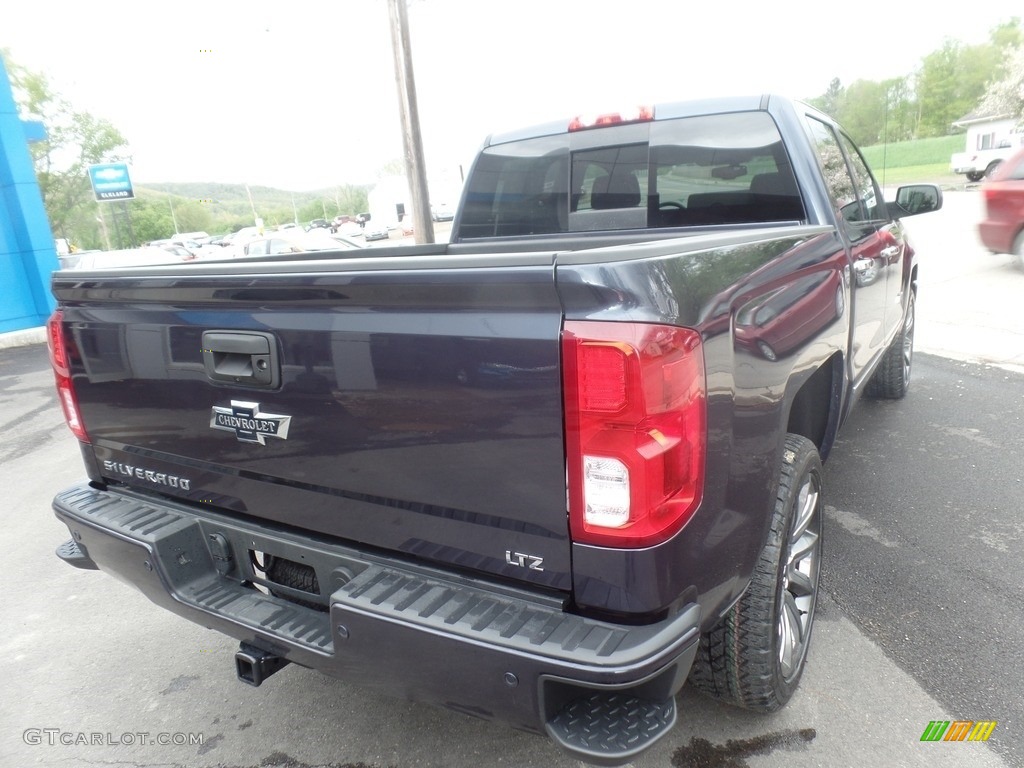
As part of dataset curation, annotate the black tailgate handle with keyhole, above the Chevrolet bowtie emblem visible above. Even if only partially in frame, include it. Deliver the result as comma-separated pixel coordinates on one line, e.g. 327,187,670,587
203,331,281,389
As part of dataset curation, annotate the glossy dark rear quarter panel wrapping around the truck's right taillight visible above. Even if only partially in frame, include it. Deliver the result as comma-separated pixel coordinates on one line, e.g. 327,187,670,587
557,226,850,623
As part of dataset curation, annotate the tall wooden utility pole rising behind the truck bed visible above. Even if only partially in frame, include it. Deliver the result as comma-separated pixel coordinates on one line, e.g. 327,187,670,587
388,0,434,243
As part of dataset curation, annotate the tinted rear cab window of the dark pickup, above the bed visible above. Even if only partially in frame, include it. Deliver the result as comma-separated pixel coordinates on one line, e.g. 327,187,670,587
460,112,806,240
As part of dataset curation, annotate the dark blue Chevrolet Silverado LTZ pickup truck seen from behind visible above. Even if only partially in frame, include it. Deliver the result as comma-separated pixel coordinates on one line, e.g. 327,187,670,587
48,95,942,765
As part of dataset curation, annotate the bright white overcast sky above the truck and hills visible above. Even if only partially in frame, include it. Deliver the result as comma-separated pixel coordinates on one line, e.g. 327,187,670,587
0,0,1024,190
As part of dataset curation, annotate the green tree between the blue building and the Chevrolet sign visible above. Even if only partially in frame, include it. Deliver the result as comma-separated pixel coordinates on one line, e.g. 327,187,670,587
2,51,128,242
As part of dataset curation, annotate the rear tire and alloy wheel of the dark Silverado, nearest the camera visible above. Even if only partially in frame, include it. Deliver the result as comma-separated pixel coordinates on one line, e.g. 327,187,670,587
689,434,823,712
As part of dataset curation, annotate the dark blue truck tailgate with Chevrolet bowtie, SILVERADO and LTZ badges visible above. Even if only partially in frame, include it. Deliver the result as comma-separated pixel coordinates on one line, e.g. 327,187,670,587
53,254,570,590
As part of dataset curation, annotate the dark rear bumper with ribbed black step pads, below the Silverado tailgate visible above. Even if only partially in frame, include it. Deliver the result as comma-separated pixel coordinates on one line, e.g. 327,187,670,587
53,484,700,764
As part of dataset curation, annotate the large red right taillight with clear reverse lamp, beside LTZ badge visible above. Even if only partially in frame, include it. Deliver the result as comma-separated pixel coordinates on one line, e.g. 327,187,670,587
562,322,707,547
